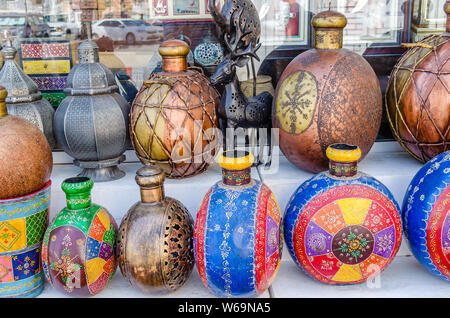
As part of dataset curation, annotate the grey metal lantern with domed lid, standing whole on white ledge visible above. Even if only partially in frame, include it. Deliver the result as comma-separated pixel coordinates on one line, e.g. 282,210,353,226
54,41,130,182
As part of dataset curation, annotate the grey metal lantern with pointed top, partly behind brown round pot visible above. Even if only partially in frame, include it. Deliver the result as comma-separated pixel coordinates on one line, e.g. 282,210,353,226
0,41,56,148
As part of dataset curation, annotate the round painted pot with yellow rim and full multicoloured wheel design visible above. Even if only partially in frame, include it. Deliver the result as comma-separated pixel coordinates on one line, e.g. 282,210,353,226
284,144,402,284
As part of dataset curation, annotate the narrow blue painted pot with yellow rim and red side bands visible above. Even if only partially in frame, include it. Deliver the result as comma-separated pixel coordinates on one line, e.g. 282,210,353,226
194,151,282,297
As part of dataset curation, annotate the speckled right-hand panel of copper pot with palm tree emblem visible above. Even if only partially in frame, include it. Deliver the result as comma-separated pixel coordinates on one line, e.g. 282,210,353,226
318,51,382,156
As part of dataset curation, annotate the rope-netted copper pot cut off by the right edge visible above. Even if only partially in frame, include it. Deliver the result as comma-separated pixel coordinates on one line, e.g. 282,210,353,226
386,1,450,162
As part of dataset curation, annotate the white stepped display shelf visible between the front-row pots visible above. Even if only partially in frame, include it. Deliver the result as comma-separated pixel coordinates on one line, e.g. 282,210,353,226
39,142,450,298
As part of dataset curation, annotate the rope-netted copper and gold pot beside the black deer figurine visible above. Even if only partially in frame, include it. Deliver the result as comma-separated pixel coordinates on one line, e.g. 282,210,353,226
130,40,219,178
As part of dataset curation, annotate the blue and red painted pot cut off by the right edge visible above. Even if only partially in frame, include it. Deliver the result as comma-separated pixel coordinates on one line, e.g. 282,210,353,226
402,151,450,281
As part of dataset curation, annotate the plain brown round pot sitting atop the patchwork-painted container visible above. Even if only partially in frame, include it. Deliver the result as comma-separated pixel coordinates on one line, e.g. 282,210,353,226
0,86,53,199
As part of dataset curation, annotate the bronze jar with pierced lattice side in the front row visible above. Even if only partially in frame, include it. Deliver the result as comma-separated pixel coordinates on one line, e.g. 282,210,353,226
116,166,195,293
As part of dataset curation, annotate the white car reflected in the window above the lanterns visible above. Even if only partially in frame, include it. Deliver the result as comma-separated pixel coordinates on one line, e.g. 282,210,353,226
92,19,163,45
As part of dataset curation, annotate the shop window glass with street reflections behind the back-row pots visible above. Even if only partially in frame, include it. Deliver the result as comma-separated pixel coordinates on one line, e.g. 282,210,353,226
0,0,445,95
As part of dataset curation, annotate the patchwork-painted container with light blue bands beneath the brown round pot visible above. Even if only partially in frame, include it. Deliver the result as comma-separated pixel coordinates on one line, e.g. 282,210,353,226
0,181,51,297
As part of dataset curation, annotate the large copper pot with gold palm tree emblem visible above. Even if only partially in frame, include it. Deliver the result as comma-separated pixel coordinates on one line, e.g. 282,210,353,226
273,11,382,173
